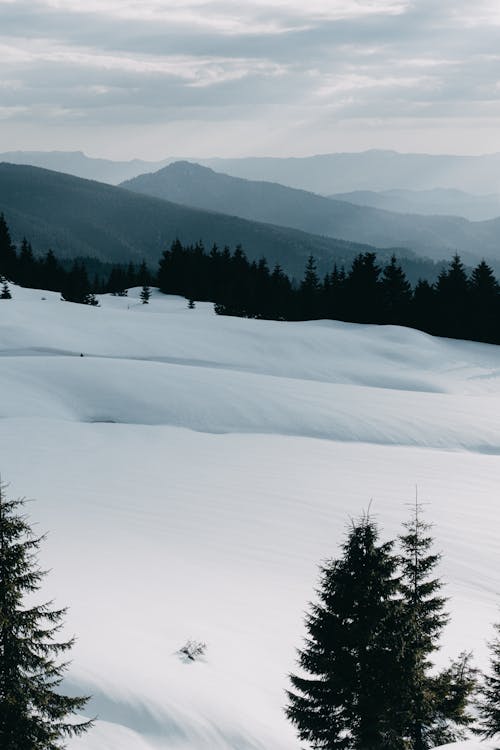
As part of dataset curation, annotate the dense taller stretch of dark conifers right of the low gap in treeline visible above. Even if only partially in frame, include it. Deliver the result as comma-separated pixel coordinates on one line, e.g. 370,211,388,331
157,240,500,343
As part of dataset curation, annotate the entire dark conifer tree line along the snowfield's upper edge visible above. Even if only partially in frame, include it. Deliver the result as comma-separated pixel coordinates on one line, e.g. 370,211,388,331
0,215,500,344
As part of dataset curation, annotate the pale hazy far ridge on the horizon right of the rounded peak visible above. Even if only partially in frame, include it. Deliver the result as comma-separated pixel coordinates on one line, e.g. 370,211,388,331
199,150,500,195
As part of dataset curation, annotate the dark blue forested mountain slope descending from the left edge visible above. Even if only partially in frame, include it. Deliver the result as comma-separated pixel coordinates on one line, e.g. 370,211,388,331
0,163,402,276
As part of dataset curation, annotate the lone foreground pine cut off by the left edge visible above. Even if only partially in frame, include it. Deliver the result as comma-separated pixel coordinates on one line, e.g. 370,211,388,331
0,484,92,750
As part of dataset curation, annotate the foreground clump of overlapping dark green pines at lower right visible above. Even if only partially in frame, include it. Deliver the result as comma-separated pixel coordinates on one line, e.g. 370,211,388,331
286,504,476,750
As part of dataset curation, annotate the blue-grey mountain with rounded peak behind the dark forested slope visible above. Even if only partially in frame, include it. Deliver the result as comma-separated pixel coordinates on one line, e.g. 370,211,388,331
122,162,500,262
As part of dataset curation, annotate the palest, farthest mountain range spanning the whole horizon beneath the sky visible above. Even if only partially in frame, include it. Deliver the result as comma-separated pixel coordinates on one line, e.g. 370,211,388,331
6,150,500,197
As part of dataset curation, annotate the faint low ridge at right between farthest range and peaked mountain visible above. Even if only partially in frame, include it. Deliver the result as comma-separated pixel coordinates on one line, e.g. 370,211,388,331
328,188,500,221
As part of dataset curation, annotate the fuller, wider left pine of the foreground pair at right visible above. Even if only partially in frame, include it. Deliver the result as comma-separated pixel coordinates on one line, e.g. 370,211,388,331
286,517,404,750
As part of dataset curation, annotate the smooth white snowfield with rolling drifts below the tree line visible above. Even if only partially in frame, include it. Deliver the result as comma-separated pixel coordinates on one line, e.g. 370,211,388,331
0,288,500,750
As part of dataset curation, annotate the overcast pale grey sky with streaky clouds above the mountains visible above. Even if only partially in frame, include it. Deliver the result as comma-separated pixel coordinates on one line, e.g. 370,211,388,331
0,0,500,159
